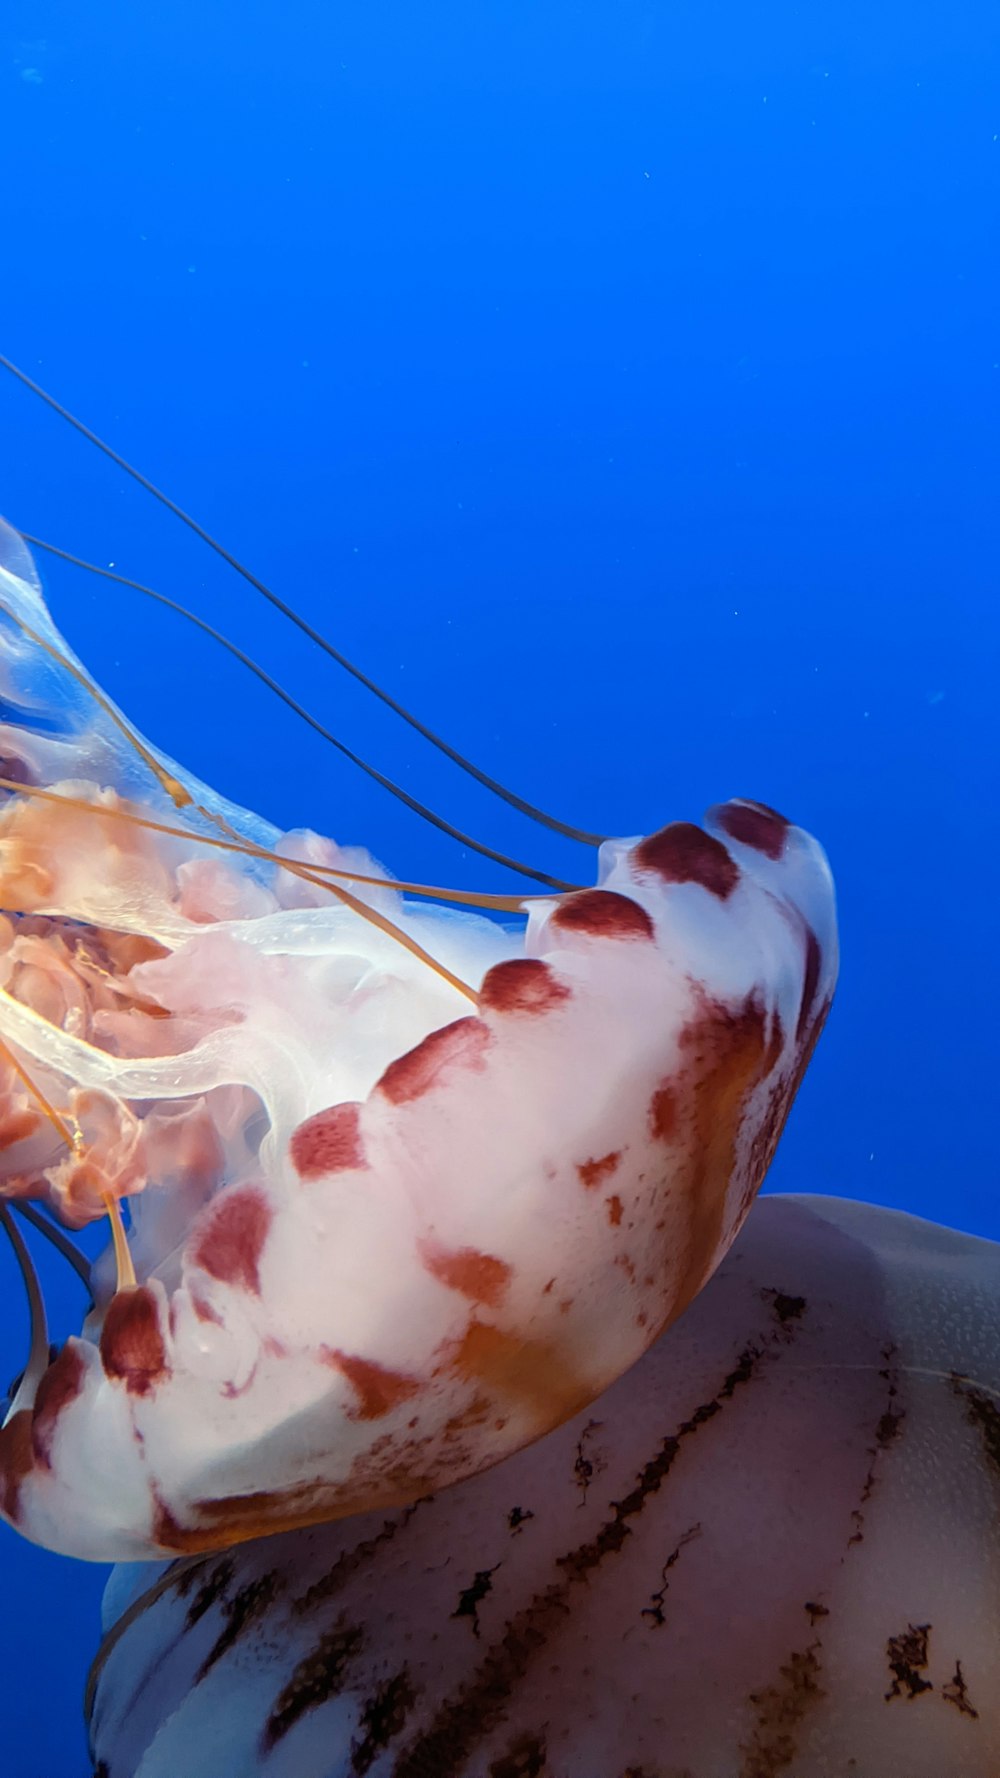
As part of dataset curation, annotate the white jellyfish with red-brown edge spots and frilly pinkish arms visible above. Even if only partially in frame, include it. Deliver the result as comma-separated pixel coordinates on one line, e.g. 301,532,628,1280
0,508,836,1559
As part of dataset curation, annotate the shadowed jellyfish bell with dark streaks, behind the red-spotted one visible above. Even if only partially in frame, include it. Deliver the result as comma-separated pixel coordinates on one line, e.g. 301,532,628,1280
91,1198,1000,1778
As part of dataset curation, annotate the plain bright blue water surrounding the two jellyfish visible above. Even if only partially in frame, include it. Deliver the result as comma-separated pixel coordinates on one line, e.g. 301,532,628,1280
0,0,1000,1778
